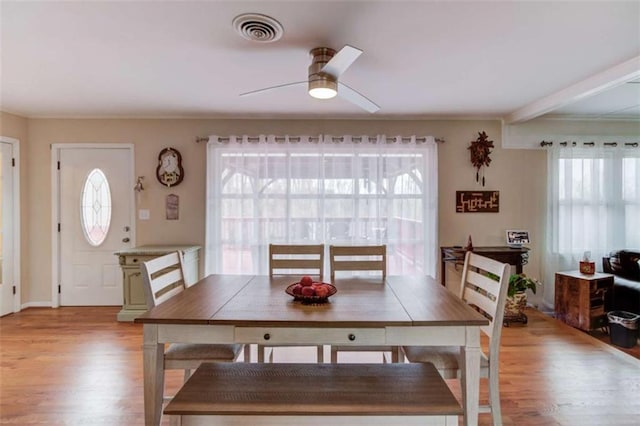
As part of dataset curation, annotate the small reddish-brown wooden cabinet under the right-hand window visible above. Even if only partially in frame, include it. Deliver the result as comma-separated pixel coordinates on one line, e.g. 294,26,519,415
555,271,613,331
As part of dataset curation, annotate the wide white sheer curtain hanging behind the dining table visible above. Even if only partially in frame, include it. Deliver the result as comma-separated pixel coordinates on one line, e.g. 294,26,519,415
205,135,438,276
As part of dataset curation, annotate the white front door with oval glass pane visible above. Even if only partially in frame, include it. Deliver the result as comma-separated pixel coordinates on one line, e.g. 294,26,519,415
58,147,134,306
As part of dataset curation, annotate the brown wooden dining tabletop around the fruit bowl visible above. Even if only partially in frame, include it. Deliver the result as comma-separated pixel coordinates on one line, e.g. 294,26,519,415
135,275,488,327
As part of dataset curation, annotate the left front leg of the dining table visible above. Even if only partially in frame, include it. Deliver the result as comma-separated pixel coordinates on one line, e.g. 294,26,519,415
142,324,164,426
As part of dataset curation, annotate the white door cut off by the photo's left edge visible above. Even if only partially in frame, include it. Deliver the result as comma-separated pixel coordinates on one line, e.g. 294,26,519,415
0,141,16,316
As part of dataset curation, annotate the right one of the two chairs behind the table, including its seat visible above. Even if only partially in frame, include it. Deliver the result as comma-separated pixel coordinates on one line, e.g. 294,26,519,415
329,244,400,364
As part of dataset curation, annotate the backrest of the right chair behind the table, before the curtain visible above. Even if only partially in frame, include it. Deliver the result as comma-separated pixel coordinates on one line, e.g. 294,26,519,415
329,245,387,279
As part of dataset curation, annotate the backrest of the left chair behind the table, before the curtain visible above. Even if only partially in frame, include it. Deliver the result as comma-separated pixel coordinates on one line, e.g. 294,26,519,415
269,244,324,278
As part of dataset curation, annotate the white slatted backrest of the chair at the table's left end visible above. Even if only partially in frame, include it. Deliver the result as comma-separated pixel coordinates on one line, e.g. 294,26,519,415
140,251,185,309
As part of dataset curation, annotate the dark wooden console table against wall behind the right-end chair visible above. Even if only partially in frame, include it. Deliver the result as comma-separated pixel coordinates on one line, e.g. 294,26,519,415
440,246,529,285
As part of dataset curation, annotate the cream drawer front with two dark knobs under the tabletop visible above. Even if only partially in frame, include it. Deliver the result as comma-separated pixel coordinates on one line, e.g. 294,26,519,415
235,327,386,346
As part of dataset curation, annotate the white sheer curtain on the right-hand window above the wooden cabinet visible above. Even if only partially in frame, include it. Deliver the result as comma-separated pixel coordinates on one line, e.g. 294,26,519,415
544,144,640,306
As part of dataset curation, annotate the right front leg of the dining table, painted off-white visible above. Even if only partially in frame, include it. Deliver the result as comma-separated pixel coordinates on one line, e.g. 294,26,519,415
460,327,480,426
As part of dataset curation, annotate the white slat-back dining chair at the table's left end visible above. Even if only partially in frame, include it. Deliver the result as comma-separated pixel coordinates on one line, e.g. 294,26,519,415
140,251,249,400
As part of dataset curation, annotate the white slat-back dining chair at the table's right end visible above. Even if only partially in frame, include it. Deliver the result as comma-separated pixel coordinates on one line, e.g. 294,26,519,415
402,251,510,425
